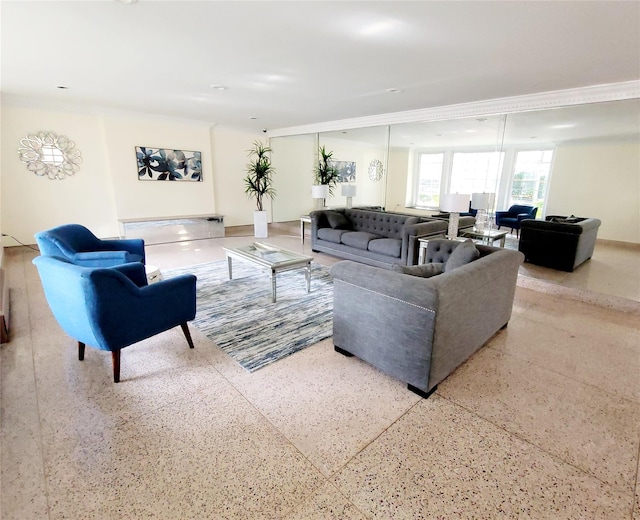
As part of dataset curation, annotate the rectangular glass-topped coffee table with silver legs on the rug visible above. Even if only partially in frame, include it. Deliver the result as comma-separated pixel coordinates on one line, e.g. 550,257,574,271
222,242,313,303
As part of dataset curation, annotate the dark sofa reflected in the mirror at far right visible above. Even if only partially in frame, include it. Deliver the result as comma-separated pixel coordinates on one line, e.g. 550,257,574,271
518,215,601,272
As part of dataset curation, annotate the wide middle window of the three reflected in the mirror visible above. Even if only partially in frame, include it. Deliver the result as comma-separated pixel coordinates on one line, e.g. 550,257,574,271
449,152,504,198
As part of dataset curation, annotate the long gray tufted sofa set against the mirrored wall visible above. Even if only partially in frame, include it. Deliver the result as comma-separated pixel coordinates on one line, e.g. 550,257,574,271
310,208,475,269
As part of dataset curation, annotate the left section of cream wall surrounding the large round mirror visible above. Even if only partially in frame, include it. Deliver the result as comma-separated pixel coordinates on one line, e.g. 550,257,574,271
0,106,118,246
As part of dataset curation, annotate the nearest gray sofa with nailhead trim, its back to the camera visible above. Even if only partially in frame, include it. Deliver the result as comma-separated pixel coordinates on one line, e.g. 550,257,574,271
331,239,524,396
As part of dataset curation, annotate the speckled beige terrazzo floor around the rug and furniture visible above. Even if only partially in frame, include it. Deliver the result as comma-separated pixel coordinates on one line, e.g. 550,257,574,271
0,229,640,520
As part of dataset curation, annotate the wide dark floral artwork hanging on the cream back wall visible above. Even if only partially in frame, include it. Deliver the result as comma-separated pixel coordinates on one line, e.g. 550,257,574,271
136,146,202,182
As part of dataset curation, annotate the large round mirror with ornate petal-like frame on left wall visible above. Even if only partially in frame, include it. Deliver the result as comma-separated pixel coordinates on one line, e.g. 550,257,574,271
18,132,82,179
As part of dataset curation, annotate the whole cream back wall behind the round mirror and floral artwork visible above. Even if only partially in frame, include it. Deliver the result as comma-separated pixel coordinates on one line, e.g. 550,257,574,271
0,105,262,246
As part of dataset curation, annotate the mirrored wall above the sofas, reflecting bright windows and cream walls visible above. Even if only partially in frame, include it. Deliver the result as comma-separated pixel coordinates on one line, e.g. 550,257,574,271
271,99,640,243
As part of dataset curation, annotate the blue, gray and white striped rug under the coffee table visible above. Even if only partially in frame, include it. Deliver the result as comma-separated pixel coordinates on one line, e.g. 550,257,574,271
162,259,333,372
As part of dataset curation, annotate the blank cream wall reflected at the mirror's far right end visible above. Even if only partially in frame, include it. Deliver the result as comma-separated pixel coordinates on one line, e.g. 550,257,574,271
546,140,640,243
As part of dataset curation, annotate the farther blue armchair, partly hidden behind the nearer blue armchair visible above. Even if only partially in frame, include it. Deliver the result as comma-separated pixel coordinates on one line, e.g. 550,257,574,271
35,224,145,267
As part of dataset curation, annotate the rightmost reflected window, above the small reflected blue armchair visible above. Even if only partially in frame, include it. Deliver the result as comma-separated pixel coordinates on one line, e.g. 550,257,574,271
509,150,553,214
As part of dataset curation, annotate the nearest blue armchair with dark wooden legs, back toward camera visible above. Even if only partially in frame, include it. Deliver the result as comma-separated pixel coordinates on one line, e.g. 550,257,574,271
33,256,196,383
